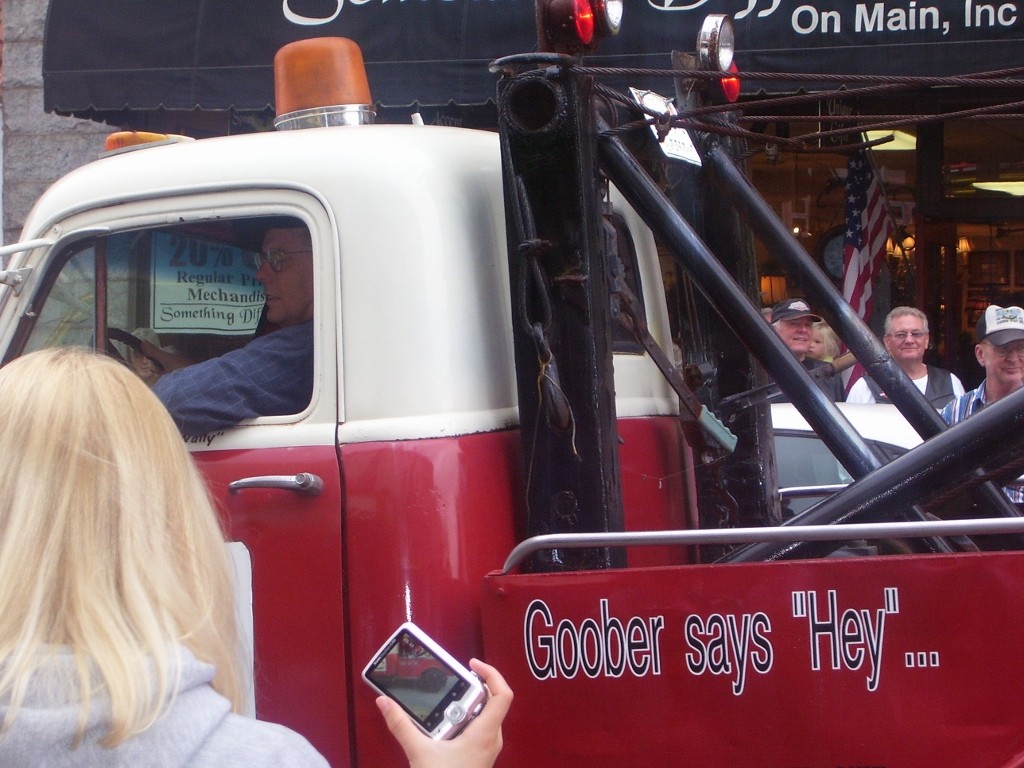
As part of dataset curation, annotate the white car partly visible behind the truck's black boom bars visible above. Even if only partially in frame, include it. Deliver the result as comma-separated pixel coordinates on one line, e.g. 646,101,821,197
771,402,922,517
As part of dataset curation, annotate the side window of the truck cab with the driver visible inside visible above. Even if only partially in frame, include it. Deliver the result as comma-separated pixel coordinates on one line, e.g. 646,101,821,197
12,217,313,434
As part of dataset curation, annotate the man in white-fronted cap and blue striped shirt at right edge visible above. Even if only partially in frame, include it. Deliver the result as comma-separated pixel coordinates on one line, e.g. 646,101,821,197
942,304,1024,505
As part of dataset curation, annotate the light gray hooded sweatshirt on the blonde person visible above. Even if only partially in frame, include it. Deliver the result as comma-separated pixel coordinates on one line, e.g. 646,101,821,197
0,649,328,768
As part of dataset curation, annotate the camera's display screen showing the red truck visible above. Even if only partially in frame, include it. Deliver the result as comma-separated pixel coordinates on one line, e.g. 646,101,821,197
367,630,469,731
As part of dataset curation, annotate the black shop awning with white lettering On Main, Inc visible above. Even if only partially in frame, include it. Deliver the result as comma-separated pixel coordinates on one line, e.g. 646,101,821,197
43,0,1024,132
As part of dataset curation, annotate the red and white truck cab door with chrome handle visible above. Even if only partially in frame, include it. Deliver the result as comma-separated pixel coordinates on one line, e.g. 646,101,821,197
6,207,350,765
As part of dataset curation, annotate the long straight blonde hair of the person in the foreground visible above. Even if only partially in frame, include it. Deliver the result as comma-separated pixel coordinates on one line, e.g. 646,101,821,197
0,348,243,746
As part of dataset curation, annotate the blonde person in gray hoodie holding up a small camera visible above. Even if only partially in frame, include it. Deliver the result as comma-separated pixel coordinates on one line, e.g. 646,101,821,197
0,348,512,768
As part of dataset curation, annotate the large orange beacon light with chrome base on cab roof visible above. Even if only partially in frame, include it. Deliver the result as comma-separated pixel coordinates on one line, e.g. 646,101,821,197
273,37,376,130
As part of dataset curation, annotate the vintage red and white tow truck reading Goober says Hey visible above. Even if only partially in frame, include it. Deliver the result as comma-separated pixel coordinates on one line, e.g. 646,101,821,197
0,7,1024,768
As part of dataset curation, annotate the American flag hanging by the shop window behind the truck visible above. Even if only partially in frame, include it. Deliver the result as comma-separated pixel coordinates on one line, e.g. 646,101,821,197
843,150,893,391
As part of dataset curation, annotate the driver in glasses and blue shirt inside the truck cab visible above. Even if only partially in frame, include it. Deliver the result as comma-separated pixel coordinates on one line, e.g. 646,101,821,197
141,219,313,435
